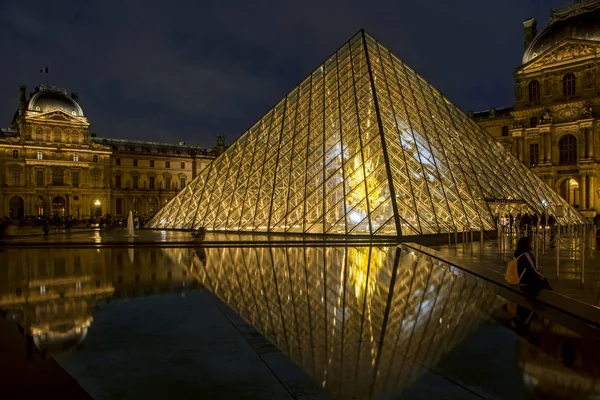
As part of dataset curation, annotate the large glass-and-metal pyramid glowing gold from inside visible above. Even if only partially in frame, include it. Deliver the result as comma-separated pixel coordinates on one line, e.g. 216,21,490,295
148,31,583,236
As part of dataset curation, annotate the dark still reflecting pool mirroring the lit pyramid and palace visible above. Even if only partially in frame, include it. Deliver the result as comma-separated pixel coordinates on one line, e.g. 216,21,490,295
0,244,600,399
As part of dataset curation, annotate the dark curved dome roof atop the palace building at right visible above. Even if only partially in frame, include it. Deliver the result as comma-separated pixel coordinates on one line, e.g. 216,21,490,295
523,0,600,64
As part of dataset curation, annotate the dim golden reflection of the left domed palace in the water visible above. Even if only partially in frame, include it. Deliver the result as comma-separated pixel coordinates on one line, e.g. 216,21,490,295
0,248,198,352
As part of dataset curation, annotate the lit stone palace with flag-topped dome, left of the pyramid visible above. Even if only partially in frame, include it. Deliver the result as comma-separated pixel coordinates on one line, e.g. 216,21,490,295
0,85,218,220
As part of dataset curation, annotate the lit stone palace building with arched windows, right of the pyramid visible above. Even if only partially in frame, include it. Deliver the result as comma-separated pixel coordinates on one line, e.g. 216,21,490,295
472,0,600,217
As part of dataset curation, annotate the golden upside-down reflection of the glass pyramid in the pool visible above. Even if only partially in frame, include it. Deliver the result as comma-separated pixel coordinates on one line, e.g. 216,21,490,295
176,246,502,399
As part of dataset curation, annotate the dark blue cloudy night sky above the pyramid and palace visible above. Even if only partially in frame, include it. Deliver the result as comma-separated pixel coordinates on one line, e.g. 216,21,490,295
0,0,572,147
